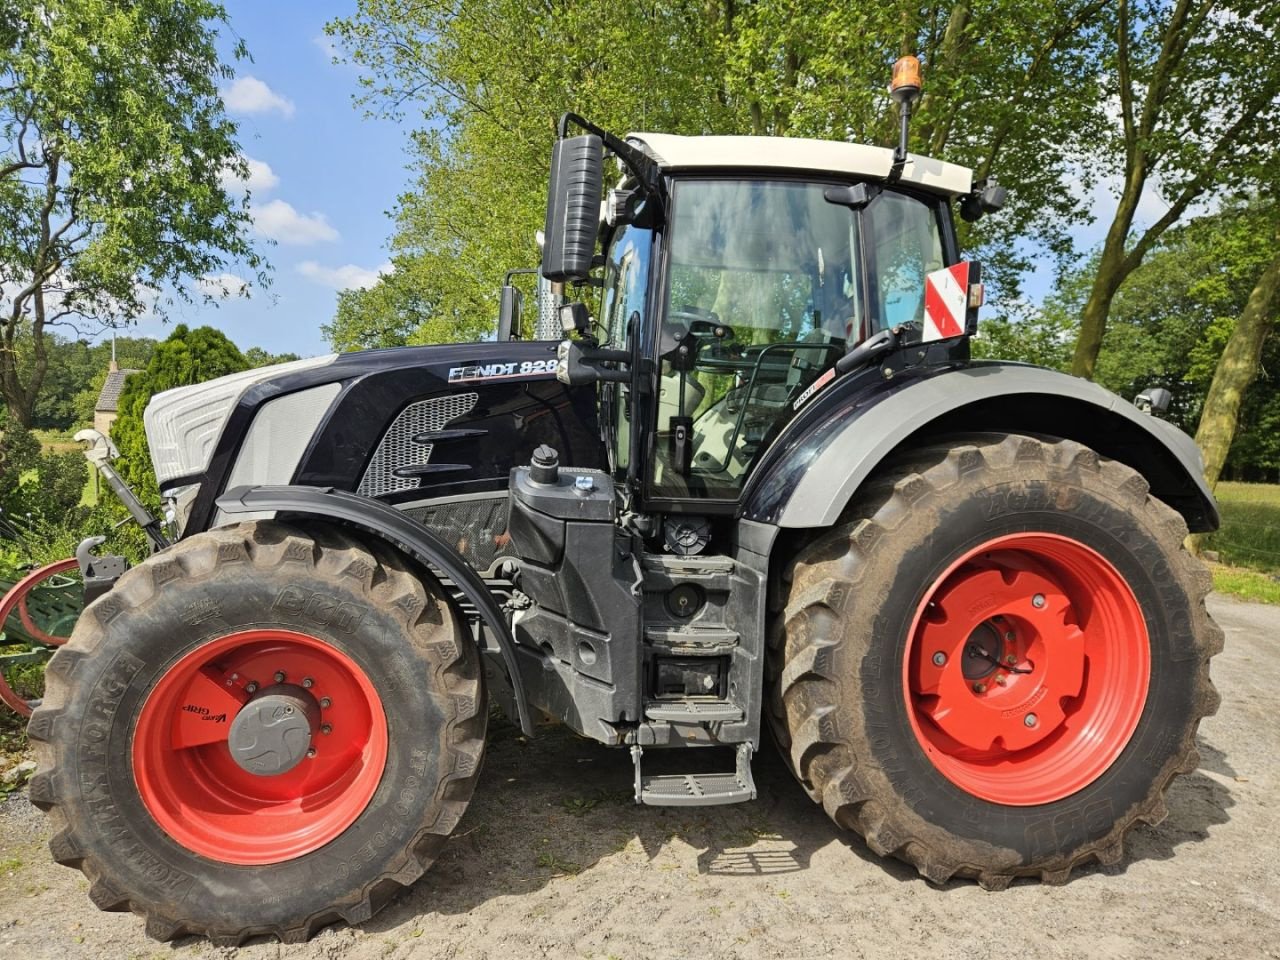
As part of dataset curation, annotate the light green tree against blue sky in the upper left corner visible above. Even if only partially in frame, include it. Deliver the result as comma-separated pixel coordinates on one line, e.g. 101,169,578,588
0,0,266,425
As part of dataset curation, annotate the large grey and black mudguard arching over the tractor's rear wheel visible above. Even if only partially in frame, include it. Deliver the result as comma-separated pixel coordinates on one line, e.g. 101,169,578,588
741,361,1219,532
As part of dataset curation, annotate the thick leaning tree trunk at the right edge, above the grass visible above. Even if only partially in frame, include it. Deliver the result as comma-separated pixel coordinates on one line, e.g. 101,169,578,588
1196,253,1280,488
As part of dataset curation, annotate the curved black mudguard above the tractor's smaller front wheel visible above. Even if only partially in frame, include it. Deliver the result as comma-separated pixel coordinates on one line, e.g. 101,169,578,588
218,486,534,736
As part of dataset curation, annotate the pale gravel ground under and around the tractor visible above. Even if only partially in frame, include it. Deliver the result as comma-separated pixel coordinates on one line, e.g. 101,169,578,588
0,596,1280,960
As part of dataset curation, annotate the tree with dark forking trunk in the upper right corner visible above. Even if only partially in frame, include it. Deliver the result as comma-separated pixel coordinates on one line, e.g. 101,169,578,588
1071,0,1280,379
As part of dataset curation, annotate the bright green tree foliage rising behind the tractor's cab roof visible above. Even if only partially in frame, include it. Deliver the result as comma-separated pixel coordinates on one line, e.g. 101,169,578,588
326,0,1107,348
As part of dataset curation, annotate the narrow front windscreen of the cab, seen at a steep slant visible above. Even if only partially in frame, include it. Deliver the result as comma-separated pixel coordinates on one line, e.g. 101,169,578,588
600,227,653,474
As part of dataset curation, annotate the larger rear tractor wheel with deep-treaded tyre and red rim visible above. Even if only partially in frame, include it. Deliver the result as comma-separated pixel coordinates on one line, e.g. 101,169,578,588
772,435,1222,888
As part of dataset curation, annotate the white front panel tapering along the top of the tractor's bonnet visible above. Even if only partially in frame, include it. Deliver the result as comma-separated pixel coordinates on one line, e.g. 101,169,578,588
142,353,338,488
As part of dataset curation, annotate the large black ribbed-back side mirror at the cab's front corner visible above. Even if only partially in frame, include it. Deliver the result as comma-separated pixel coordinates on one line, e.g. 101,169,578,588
543,133,604,283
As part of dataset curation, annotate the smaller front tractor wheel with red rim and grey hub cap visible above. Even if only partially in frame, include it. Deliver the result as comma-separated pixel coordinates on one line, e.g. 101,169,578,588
29,522,486,943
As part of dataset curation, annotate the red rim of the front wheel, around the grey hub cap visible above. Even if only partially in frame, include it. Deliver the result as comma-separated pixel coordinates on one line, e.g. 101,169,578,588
133,630,387,864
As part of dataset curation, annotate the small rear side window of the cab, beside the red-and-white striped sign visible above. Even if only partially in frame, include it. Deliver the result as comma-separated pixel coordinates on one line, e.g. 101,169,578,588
867,191,946,330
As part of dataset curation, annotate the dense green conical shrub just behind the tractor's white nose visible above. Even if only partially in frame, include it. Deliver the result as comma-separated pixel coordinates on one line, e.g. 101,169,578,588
111,324,248,503
